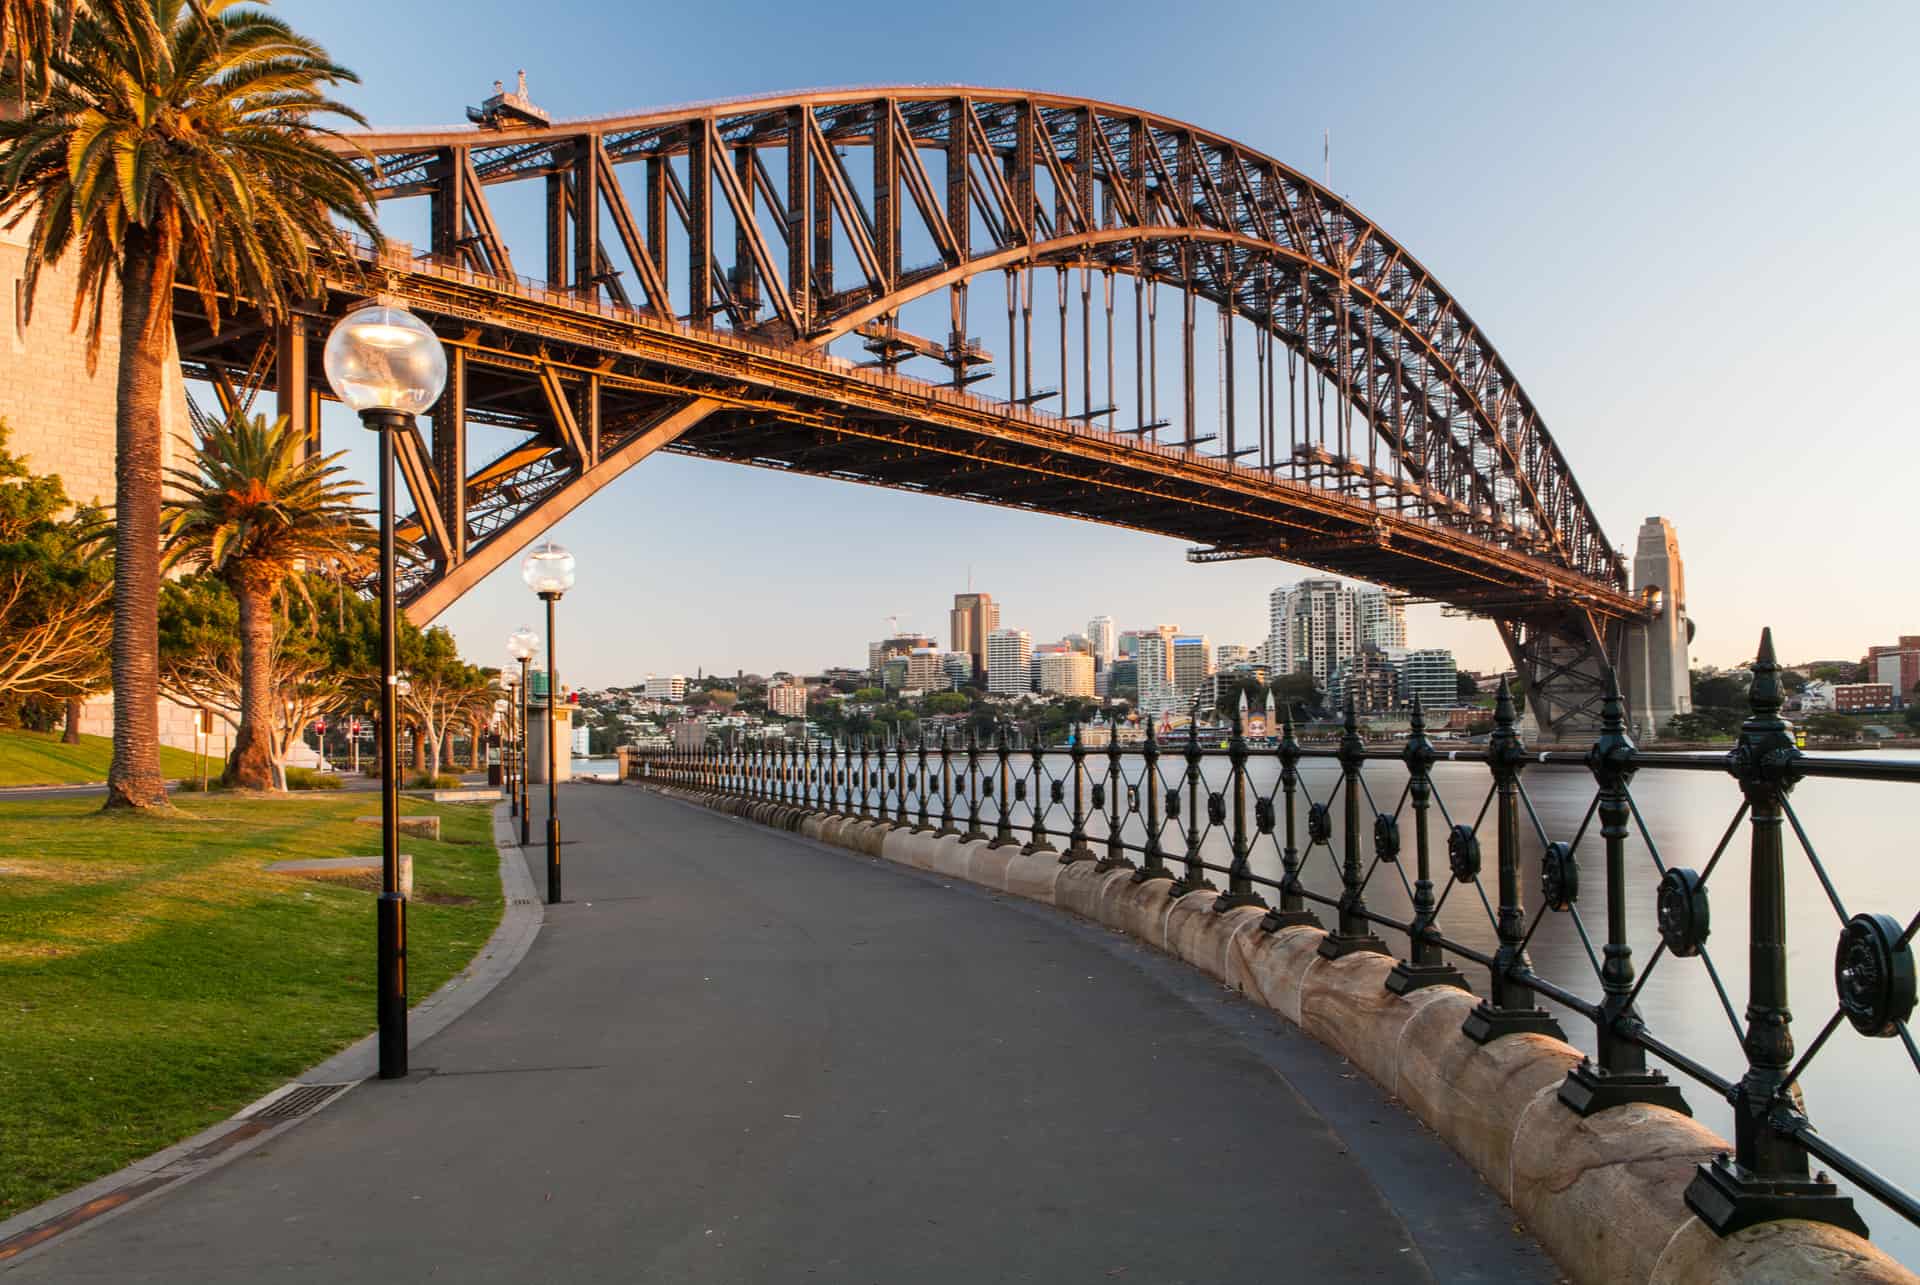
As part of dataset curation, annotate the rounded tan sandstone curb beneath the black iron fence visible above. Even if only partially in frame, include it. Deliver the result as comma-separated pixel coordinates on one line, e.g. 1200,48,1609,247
647,784,1920,1285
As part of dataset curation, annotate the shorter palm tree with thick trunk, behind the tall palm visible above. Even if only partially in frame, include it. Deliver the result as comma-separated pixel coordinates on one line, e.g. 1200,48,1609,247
163,415,374,789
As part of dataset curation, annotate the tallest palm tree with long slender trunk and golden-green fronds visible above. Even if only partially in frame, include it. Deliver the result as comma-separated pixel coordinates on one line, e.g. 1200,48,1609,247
0,0,378,807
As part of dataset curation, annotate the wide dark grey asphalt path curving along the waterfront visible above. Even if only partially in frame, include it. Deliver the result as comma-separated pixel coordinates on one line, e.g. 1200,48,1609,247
15,786,1557,1285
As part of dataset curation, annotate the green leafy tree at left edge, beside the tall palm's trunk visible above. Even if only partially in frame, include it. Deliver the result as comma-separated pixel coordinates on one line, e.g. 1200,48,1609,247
0,421,113,732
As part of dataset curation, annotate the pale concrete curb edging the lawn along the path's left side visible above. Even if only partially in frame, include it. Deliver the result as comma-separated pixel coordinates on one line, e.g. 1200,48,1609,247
0,805,545,1272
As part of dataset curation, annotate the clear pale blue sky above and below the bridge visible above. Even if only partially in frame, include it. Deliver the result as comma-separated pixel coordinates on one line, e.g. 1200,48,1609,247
284,0,1920,686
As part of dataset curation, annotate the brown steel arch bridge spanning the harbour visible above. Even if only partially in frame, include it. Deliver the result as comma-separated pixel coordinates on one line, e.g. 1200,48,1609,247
177,86,1647,734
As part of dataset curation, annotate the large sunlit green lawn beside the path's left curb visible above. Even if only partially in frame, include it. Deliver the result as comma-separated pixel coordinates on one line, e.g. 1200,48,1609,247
0,795,501,1218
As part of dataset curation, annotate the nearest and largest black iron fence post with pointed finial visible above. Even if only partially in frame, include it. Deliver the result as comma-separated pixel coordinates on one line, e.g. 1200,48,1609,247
1686,630,1866,1237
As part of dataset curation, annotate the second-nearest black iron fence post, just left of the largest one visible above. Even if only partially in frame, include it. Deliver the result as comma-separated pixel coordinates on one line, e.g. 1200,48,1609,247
1559,668,1693,1116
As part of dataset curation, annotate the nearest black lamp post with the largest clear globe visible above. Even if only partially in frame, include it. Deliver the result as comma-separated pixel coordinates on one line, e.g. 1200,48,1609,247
323,303,447,1079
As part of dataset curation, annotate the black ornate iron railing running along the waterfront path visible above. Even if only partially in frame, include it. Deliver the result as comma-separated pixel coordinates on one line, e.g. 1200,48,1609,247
632,634,1920,1235
